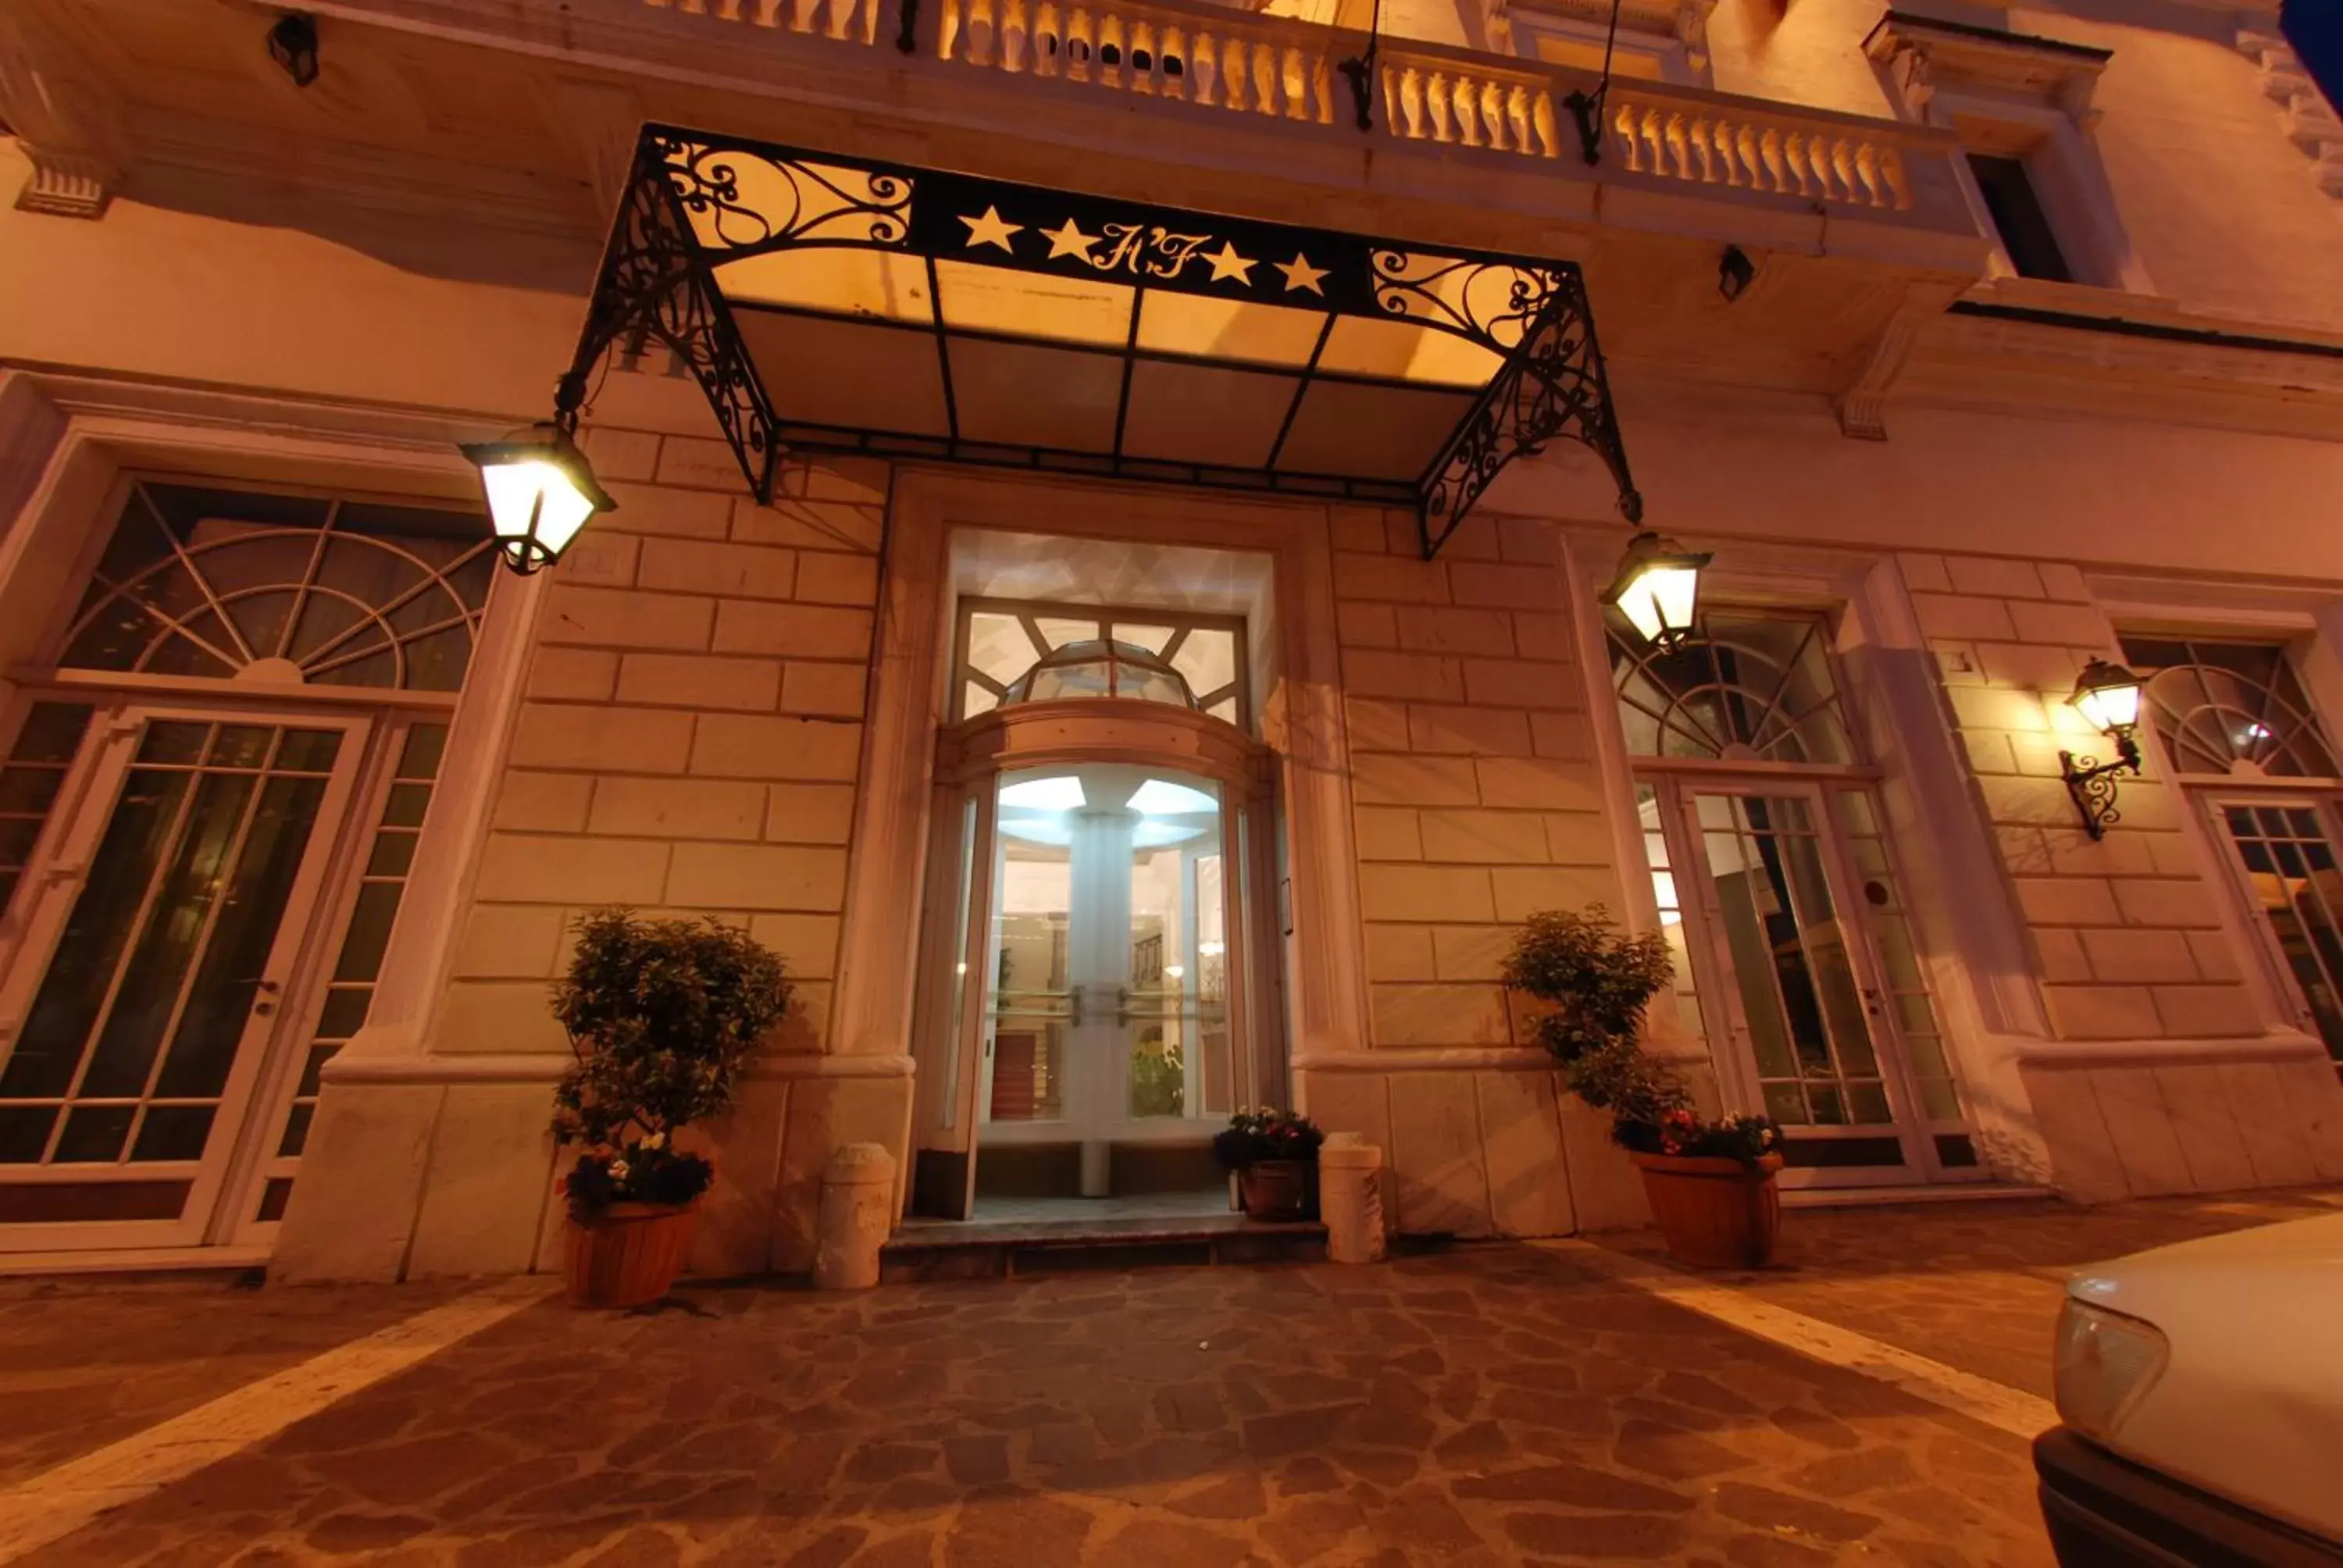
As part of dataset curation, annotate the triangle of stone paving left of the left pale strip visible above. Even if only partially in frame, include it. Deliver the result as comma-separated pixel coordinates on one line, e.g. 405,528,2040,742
0,1275,455,1488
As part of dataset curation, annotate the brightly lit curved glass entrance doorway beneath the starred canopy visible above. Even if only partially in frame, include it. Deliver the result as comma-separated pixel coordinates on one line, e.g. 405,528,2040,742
911,607,1282,1219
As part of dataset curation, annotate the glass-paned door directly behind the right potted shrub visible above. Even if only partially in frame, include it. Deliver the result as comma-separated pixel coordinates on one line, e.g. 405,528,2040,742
1645,780,1975,1186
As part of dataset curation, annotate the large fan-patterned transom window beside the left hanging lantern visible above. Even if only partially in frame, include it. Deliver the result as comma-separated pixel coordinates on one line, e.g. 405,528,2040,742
59,480,494,691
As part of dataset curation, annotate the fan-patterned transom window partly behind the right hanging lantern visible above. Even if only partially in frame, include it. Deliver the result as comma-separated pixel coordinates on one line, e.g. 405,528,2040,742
1607,607,1858,764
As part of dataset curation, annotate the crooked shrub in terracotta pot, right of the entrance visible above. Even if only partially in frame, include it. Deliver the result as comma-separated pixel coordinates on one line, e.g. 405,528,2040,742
1504,905,1781,1268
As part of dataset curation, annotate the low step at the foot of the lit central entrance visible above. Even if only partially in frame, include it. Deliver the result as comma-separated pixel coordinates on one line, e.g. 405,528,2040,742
879,1214,1326,1285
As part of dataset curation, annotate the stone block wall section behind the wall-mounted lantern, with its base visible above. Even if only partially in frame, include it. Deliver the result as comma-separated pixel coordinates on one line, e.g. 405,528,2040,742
1900,553,2343,1203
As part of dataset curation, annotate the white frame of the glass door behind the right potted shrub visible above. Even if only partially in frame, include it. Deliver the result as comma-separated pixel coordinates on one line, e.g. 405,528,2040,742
1635,764,1992,1188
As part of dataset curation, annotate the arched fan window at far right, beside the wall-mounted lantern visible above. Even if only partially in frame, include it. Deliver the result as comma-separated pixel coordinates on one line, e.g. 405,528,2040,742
2123,637,2343,778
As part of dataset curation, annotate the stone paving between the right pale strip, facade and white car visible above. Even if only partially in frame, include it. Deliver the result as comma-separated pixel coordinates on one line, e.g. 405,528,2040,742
1603,1186,2343,1399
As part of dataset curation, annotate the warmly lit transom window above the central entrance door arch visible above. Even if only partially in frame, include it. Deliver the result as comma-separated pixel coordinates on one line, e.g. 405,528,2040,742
951,600,1251,729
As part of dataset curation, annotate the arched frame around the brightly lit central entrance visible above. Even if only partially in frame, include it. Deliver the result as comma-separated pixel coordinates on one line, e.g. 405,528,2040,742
904,698,1277,1219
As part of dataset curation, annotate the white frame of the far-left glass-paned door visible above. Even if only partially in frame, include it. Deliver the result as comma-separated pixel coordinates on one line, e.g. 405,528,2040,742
0,691,387,1256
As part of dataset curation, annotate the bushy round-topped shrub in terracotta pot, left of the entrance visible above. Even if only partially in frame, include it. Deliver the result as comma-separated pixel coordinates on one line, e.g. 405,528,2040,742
553,910,790,1308
